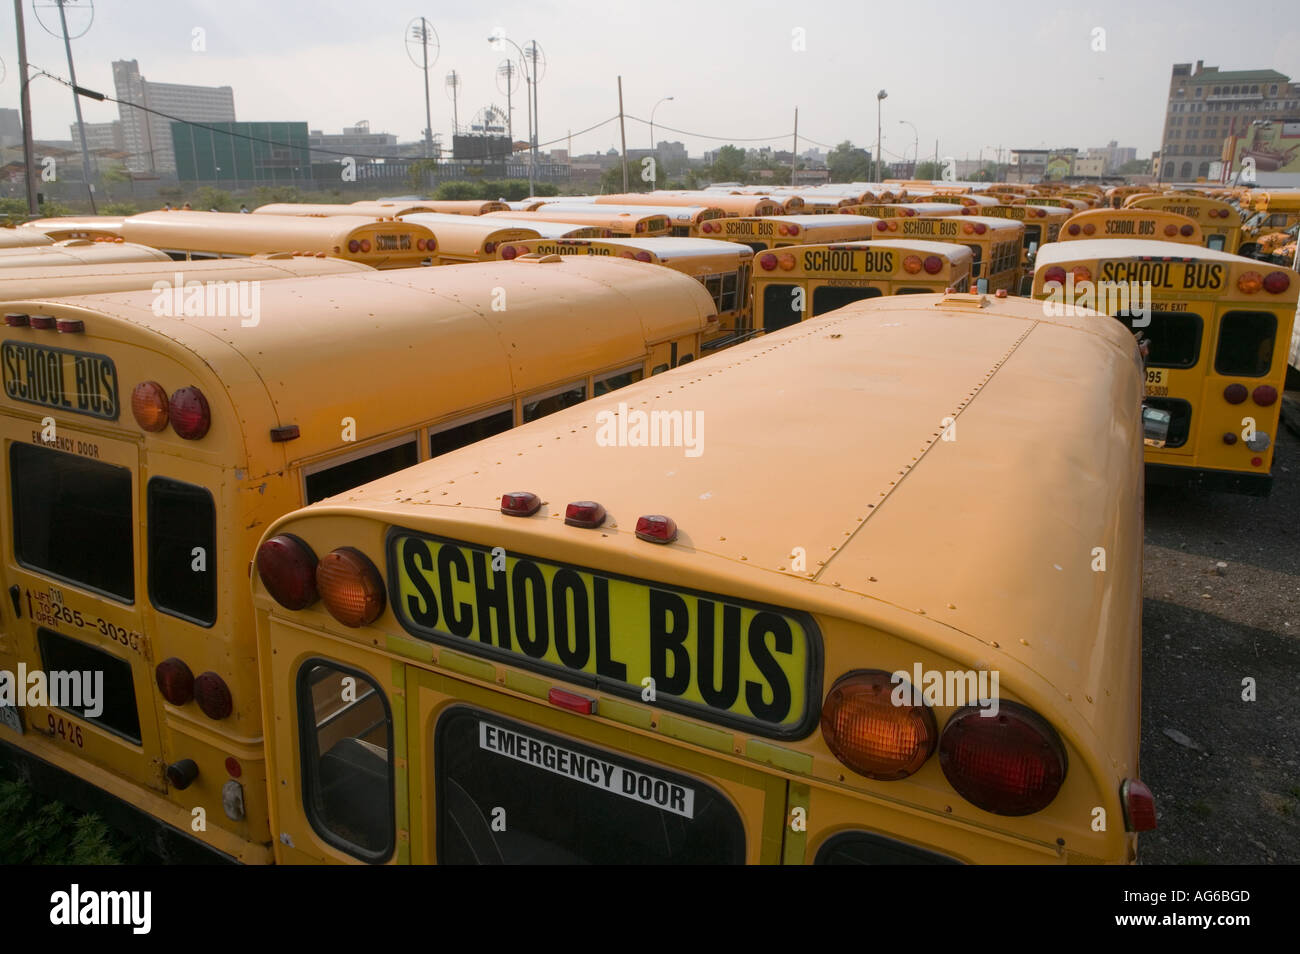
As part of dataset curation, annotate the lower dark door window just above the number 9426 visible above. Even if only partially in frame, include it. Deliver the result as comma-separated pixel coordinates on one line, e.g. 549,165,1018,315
36,629,140,745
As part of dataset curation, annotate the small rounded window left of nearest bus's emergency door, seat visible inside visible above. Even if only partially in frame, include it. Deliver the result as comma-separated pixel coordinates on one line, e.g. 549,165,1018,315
296,659,397,862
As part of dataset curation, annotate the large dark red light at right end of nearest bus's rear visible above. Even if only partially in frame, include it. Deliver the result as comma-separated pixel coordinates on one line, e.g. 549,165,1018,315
939,699,1067,815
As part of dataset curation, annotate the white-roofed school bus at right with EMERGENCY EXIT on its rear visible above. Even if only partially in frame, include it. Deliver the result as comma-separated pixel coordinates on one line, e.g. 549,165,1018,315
1034,239,1300,495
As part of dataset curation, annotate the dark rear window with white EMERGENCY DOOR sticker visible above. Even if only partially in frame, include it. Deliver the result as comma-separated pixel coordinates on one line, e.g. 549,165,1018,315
434,708,745,864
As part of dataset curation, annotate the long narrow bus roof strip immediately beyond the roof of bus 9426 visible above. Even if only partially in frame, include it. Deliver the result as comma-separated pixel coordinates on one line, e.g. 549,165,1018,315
0,255,372,302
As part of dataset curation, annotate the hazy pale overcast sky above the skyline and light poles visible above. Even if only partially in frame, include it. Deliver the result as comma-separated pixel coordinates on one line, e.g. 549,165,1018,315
0,0,1300,159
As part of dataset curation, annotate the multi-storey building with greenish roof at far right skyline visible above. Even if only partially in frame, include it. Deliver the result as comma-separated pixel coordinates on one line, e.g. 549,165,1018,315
1160,60,1300,181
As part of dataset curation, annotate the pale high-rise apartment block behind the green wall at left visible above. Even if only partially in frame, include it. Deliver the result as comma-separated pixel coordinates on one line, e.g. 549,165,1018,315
113,60,235,175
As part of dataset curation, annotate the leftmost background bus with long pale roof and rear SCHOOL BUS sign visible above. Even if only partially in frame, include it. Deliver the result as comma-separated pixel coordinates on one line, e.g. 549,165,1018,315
122,211,437,268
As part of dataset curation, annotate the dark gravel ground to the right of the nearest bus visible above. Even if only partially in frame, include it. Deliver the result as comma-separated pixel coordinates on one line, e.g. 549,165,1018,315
1139,394,1300,864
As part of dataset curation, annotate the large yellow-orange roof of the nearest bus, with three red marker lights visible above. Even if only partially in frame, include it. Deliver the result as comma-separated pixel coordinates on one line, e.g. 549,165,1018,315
282,295,1143,746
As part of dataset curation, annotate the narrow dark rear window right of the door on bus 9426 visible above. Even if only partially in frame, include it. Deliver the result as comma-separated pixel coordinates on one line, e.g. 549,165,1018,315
148,477,217,626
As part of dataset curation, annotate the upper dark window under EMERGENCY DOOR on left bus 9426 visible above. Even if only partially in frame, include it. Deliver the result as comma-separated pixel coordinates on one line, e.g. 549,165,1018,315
9,443,135,603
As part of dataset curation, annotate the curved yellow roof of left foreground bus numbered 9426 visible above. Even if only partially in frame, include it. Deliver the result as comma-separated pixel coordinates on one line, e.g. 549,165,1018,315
5,256,716,473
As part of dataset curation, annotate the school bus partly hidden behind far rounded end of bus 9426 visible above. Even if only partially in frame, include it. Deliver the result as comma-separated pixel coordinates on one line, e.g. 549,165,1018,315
497,237,754,351
